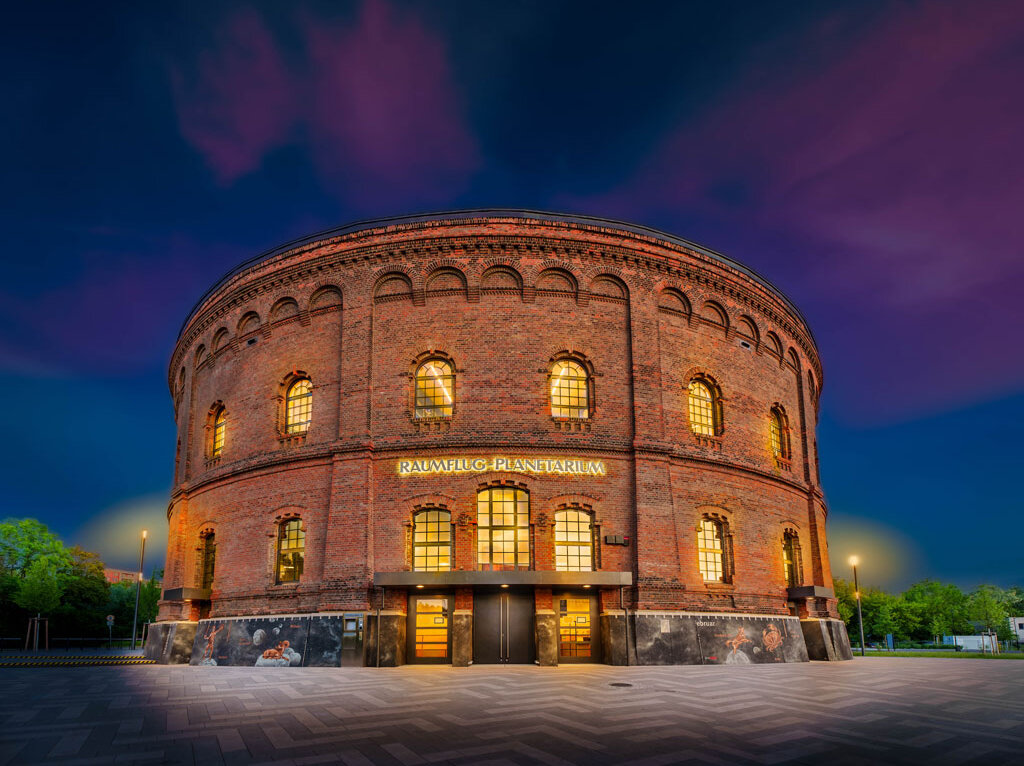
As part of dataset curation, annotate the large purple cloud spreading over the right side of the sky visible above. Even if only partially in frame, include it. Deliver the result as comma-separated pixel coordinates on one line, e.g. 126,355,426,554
563,3,1024,422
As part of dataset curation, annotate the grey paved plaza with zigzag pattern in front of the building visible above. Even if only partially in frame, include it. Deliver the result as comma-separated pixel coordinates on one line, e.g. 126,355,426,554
0,658,1024,765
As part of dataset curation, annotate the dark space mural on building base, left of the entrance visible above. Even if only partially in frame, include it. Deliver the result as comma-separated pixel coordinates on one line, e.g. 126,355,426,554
190,615,361,668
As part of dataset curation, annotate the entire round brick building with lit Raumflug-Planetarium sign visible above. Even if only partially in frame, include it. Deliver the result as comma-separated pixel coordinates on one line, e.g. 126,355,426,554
147,210,850,666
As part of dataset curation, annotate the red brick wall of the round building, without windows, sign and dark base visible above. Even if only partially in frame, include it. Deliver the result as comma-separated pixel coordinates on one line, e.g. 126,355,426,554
160,213,836,647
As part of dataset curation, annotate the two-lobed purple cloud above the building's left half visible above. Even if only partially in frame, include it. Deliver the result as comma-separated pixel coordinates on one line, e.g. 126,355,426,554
172,0,479,209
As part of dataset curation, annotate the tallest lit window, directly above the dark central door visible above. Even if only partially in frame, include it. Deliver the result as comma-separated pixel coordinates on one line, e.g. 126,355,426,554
476,486,529,569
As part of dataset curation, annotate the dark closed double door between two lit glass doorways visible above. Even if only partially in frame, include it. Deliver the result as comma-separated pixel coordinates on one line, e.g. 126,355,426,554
473,588,537,665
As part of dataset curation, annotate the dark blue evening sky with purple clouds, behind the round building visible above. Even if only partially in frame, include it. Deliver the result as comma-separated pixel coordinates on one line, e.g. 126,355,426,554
0,0,1024,587
